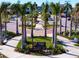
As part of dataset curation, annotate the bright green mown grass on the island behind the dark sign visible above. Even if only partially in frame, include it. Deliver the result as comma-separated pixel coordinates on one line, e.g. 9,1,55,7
17,37,52,48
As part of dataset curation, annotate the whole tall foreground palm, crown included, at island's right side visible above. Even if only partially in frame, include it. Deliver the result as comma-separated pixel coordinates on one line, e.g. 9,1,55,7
50,3,60,48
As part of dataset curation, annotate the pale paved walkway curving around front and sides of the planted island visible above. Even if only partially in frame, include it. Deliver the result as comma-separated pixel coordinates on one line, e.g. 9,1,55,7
0,34,79,58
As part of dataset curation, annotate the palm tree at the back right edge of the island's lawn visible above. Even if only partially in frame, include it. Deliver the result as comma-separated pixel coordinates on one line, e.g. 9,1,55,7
42,3,50,38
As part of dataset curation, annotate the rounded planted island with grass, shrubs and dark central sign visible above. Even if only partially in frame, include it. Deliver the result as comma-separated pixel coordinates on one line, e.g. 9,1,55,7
15,36,66,55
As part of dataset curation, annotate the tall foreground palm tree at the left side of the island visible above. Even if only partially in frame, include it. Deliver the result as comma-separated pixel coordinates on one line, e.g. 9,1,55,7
18,4,27,49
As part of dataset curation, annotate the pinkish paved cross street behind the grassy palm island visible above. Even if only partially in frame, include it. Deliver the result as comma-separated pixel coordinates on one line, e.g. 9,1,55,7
7,21,78,36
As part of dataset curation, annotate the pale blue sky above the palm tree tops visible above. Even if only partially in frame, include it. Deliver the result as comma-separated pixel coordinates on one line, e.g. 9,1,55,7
0,0,79,7
